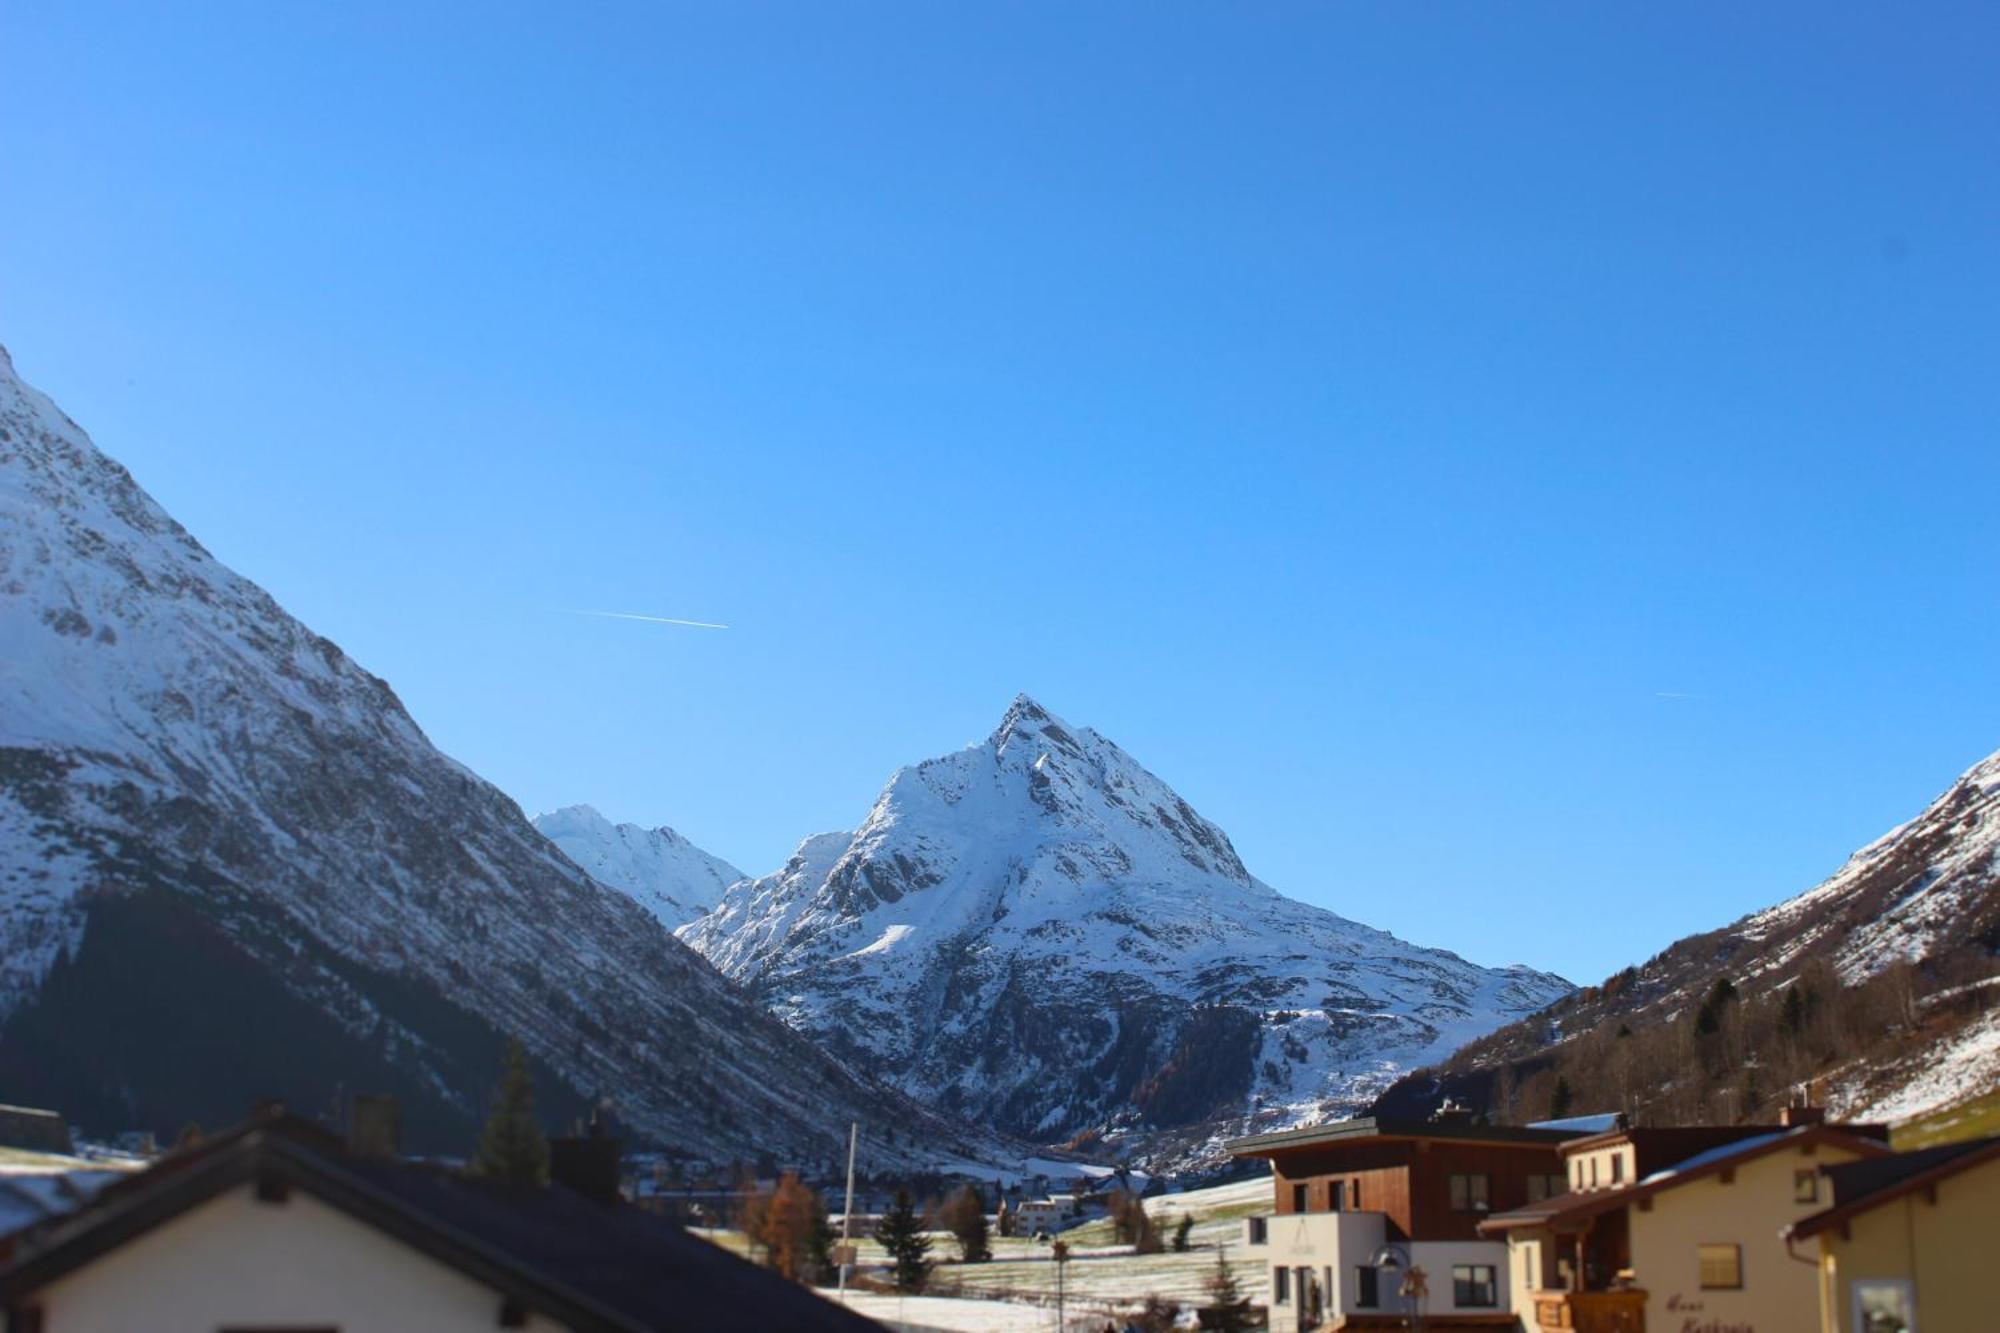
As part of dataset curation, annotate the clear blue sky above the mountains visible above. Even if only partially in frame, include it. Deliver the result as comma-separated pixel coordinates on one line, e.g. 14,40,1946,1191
0,0,2000,981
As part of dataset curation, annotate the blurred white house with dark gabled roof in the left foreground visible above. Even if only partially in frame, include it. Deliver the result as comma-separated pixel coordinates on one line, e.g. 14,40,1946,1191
0,1113,878,1333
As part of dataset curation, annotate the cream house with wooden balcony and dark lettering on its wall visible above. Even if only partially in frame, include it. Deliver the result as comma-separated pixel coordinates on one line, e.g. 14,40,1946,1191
1480,1111,1888,1333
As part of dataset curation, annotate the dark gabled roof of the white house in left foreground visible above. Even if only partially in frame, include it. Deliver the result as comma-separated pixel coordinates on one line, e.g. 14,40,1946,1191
0,1119,878,1333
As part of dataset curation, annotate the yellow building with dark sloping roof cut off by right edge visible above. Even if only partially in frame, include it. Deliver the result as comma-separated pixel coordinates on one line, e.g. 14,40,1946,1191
1786,1139,2000,1333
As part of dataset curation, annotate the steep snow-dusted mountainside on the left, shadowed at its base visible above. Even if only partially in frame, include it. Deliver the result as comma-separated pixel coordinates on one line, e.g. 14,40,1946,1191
0,344,992,1157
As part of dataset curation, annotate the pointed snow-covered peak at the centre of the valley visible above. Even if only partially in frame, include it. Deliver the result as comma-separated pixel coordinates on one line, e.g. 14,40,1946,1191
682,697,1568,1139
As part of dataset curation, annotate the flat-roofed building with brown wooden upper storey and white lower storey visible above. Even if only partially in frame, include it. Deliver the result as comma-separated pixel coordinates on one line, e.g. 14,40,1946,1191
1228,1113,1610,1333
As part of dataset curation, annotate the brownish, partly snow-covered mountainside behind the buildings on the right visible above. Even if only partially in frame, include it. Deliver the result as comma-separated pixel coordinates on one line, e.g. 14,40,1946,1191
1382,740,2000,1119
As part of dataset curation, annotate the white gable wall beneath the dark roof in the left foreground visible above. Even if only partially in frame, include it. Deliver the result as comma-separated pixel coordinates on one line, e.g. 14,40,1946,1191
36,1185,562,1333
